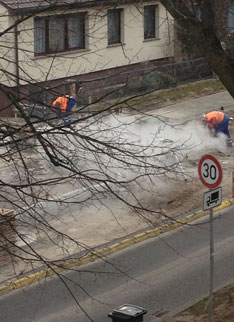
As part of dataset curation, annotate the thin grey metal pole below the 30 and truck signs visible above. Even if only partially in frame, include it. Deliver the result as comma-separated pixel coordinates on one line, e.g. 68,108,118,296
209,208,214,322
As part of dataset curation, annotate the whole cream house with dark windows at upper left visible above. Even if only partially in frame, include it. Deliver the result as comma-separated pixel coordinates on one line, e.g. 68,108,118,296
0,0,173,113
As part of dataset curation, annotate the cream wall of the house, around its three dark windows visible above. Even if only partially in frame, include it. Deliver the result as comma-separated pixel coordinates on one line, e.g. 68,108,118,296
11,2,173,85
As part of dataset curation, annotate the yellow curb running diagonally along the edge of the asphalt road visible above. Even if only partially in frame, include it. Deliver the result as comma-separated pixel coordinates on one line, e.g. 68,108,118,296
0,198,234,296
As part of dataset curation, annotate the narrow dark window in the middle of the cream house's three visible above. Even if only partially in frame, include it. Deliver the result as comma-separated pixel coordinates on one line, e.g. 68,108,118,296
107,9,122,45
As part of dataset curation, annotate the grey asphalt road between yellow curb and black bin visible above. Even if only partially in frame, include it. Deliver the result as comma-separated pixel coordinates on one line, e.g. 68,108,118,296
0,207,234,322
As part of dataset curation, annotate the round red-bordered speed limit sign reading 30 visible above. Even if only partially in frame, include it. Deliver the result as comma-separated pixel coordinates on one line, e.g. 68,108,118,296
198,155,223,188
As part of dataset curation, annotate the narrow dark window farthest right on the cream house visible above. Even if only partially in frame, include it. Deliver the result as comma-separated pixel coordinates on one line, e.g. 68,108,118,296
144,5,158,39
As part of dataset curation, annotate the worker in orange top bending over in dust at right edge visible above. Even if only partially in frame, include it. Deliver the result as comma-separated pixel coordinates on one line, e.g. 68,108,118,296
204,108,232,147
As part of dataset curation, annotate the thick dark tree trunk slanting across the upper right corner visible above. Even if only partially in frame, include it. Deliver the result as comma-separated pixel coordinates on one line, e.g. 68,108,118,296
161,0,234,98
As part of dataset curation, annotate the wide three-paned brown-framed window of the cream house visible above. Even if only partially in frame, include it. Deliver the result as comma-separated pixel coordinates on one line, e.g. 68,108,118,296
34,13,86,55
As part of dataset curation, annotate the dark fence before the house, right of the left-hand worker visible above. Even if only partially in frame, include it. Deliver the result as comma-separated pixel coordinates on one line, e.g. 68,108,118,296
79,58,213,104
